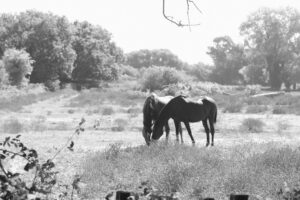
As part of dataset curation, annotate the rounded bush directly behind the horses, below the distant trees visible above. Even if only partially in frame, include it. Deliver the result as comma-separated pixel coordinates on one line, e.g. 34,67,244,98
142,66,182,91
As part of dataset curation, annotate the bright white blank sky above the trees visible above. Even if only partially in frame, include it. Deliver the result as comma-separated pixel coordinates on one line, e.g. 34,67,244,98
0,0,300,64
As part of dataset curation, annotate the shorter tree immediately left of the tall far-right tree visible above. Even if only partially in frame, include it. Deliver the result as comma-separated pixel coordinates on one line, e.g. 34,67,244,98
208,36,246,84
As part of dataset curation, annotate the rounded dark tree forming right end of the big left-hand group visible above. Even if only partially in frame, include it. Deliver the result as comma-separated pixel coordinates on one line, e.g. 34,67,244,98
72,22,123,85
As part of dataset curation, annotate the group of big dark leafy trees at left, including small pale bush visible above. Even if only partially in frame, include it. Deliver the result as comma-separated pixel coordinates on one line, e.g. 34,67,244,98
0,10,124,88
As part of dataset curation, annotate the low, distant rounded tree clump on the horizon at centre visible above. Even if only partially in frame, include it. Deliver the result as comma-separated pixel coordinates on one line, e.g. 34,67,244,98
126,49,185,69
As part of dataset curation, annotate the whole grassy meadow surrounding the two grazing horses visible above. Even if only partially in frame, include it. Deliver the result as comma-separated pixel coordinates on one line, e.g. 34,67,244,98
0,80,300,199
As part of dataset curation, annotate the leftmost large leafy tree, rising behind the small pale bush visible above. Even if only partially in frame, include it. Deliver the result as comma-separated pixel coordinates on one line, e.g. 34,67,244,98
0,11,75,88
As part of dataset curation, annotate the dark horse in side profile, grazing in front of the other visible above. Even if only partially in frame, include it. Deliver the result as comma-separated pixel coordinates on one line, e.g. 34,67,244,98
151,95,217,146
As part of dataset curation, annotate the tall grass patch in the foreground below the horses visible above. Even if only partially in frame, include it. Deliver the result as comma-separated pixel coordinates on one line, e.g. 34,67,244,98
83,143,300,200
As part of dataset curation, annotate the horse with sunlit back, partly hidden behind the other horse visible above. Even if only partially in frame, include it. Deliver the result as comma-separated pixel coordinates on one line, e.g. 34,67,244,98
143,93,183,145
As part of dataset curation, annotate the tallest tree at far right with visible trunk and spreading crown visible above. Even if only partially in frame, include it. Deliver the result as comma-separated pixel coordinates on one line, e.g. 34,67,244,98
240,8,300,90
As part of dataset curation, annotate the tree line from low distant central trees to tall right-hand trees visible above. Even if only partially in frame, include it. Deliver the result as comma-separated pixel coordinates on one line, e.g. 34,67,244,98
127,8,300,90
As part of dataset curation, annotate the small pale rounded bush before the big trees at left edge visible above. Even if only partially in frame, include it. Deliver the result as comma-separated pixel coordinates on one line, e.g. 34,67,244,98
2,49,34,86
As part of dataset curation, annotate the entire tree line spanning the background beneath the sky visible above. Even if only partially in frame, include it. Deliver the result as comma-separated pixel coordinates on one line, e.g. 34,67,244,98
0,8,300,90
